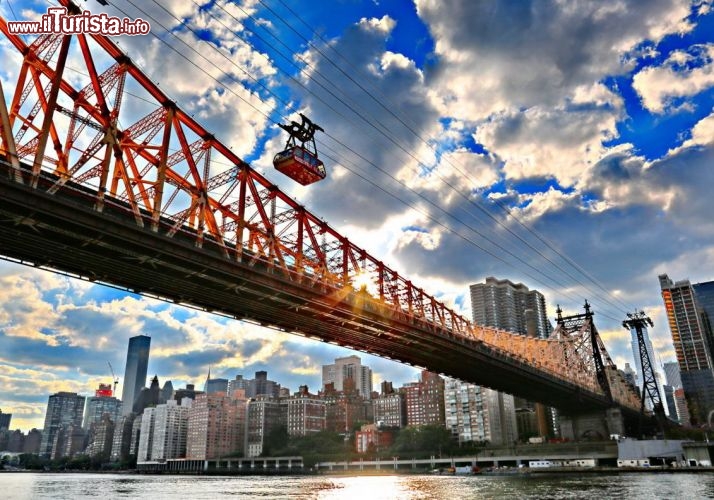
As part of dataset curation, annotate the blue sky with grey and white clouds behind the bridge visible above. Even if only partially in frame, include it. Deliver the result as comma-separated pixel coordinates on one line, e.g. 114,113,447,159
0,0,714,431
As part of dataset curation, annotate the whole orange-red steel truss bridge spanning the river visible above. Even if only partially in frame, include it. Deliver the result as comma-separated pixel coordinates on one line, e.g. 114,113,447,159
0,0,640,426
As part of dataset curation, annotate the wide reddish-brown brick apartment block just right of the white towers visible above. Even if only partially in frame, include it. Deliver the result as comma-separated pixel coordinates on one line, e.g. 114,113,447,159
186,392,248,460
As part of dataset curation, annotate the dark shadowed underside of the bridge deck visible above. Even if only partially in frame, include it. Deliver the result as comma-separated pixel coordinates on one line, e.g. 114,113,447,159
0,166,636,413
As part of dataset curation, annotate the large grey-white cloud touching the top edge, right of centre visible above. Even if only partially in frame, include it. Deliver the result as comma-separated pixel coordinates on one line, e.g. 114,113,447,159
416,0,692,120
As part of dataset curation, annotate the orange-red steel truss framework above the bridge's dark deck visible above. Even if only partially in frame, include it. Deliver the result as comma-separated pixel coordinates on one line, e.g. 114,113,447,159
0,0,640,410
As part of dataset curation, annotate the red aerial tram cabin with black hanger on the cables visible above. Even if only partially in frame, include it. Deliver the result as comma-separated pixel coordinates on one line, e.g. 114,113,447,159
273,113,327,186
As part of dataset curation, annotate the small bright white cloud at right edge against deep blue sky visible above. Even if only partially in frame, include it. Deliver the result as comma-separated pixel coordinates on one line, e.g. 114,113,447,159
632,43,714,114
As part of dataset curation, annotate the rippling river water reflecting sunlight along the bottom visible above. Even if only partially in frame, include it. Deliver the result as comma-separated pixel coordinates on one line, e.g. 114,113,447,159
0,473,714,500
